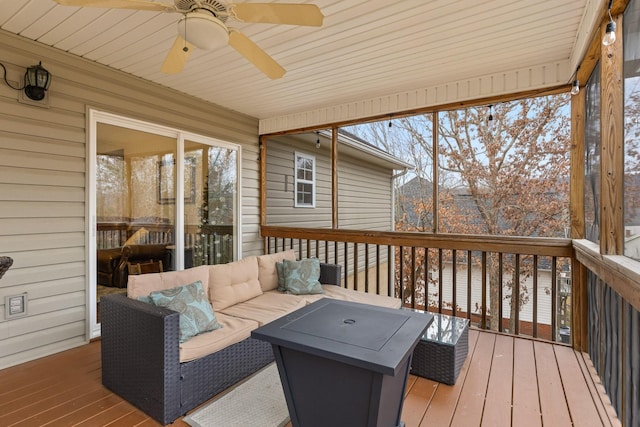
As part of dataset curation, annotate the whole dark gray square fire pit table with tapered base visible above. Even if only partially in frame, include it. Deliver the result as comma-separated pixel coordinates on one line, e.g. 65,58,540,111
251,298,433,427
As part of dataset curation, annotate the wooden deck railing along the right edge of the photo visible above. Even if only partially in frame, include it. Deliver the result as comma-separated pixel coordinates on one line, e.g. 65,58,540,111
574,240,640,426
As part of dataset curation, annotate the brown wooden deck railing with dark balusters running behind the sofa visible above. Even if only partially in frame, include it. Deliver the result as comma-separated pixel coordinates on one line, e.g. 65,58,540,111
261,226,573,343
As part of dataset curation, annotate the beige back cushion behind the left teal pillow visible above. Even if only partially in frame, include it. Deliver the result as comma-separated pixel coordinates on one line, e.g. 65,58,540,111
127,265,209,298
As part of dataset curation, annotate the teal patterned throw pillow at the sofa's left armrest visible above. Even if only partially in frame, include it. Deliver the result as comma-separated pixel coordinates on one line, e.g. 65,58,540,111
149,280,222,343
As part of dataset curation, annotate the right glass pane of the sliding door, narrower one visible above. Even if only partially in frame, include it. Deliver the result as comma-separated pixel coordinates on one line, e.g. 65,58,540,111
184,141,238,267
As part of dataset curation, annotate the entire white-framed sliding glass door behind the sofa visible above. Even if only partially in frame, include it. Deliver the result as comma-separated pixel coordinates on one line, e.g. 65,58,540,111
88,111,240,336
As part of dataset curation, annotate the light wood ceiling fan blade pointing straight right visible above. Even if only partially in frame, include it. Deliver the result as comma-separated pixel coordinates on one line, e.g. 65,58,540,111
230,3,324,27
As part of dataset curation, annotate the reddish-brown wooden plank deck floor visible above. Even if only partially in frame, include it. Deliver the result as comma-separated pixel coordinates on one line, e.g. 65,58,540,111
0,330,621,427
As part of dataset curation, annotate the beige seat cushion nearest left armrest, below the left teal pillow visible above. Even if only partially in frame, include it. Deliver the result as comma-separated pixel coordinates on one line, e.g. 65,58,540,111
180,313,258,362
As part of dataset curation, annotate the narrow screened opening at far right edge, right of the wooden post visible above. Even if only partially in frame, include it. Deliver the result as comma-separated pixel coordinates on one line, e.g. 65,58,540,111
623,0,640,261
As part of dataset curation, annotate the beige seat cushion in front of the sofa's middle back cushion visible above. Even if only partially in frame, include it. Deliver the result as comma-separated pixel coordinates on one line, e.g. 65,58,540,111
222,291,307,326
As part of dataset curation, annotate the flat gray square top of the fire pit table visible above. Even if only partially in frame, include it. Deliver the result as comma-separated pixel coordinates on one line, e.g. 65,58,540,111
251,298,433,375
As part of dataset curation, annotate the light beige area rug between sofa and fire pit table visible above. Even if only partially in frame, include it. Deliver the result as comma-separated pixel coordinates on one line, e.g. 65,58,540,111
184,363,289,427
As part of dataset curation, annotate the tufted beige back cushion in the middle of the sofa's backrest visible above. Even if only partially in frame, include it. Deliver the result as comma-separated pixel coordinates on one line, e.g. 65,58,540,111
209,256,262,312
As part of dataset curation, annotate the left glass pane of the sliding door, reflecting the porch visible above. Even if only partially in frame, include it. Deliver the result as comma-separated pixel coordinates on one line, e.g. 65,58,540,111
95,123,176,322
